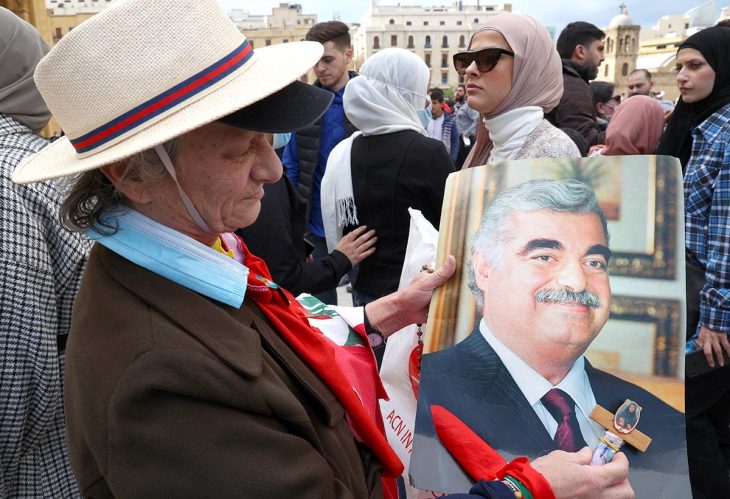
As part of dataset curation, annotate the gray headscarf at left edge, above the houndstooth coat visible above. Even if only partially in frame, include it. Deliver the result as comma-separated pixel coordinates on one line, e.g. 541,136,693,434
0,7,51,132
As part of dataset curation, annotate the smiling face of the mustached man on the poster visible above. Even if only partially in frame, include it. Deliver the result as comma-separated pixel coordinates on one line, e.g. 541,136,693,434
472,210,611,362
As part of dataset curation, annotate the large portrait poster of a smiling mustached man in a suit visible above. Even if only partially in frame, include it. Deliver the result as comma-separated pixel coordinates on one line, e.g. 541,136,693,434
410,156,691,498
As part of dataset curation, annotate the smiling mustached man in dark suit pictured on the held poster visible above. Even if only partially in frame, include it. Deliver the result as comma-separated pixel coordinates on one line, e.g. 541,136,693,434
410,179,690,498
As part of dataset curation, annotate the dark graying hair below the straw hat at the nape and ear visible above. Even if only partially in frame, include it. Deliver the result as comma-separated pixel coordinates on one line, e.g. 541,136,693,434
59,136,184,234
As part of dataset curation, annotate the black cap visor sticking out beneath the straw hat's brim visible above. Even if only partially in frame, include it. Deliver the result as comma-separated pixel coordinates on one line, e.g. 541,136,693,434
219,81,335,133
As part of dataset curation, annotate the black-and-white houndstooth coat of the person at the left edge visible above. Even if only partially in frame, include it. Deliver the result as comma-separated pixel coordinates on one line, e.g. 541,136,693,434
0,114,89,498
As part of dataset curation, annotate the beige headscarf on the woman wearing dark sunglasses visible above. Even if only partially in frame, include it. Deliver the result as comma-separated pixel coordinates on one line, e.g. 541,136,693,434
464,13,563,168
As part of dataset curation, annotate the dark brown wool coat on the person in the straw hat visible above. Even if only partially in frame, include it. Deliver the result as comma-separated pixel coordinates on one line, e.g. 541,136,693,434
65,245,382,499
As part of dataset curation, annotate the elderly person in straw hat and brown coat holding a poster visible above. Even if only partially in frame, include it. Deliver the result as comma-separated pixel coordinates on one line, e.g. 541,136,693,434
13,0,627,498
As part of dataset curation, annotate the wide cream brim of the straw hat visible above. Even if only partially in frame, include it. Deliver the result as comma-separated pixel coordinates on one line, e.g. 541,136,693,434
11,41,327,184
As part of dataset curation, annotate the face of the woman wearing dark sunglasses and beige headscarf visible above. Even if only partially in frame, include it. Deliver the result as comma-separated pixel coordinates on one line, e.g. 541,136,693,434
464,30,514,114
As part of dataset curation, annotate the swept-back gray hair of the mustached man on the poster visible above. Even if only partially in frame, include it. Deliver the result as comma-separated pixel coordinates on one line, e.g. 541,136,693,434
467,179,608,305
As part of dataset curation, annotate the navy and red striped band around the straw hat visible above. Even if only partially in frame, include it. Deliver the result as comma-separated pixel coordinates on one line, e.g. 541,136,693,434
71,41,253,153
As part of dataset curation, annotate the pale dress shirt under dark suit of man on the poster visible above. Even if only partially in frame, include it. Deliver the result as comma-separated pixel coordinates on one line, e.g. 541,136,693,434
479,319,606,450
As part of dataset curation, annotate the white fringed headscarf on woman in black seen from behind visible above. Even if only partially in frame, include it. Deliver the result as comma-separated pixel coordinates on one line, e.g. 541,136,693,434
320,48,430,251
